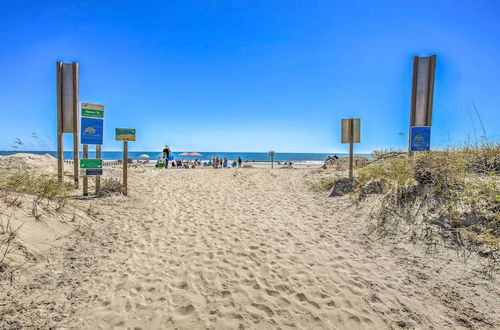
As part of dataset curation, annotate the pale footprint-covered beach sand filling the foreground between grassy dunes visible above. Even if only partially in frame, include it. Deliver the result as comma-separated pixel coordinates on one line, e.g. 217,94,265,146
0,153,500,329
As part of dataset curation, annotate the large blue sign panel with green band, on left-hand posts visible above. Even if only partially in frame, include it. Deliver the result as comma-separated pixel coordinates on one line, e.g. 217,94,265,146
81,103,104,144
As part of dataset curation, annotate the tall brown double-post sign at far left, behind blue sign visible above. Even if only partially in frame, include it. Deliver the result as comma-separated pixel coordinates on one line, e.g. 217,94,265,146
56,62,79,188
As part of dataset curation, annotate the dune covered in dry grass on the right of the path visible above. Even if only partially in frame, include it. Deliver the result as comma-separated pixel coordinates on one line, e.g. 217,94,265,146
354,144,500,266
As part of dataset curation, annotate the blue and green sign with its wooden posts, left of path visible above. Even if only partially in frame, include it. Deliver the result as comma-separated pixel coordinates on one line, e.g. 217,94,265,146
81,103,104,196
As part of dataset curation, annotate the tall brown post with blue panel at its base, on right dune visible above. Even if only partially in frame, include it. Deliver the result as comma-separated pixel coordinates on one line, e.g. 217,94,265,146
408,55,436,154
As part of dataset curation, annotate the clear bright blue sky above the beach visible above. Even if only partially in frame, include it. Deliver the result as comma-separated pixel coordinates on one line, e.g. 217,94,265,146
0,0,500,152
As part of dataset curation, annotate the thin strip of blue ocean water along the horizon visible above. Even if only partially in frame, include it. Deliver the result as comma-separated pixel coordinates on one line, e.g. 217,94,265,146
0,151,370,162
